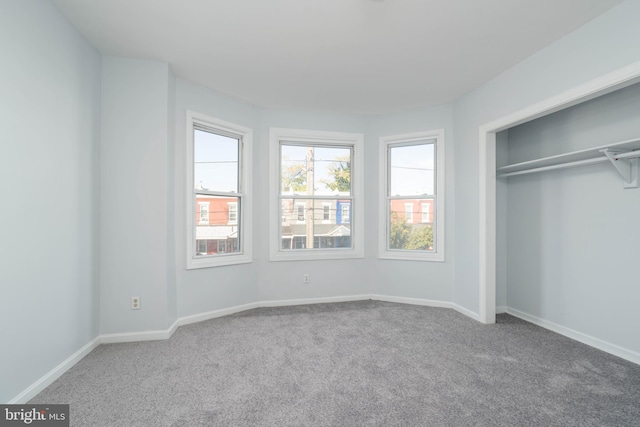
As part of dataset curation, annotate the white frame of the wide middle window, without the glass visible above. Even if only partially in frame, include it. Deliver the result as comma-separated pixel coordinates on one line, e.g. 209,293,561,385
269,128,365,261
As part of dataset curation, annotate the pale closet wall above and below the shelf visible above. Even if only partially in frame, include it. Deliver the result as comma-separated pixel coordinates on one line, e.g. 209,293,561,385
506,84,640,353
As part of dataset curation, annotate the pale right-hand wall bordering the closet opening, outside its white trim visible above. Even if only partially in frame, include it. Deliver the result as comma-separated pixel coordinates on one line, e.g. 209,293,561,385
453,1,640,312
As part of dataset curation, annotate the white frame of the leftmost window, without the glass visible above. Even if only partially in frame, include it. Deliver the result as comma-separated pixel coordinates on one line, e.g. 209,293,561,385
185,110,253,270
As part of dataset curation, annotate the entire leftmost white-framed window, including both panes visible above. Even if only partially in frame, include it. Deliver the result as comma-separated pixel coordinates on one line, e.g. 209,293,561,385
187,111,252,268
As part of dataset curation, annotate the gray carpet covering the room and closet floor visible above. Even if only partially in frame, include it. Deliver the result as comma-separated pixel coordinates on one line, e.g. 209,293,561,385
31,301,640,427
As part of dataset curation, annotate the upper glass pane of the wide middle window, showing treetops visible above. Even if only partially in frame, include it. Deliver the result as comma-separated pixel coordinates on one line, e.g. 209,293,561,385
280,144,351,196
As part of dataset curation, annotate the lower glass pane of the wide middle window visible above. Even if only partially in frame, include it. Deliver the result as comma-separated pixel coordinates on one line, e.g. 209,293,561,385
280,199,352,250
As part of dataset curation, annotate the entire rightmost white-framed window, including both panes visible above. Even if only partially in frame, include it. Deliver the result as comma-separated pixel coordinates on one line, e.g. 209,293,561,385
380,130,444,261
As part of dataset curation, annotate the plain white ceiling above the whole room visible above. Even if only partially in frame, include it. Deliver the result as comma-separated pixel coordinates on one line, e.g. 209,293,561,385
53,0,621,113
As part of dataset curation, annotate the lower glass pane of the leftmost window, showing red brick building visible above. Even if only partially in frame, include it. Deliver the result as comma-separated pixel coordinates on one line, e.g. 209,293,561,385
196,194,240,256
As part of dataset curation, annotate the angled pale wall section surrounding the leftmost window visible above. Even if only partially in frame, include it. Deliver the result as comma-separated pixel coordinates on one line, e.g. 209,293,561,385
174,79,263,317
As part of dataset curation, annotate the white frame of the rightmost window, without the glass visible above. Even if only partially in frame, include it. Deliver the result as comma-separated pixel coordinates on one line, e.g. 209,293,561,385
378,129,445,262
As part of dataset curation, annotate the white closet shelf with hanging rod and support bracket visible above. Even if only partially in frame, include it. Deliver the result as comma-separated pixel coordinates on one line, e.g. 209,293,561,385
496,138,640,188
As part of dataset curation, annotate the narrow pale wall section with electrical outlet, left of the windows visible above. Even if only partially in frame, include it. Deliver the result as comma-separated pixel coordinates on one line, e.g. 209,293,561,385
100,56,176,334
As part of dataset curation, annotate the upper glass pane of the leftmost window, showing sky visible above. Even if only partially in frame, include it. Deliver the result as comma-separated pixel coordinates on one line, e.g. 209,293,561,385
193,129,240,193
